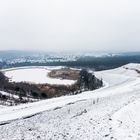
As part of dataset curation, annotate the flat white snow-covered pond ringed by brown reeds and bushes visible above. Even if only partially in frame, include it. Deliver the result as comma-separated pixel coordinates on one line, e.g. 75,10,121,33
3,67,76,85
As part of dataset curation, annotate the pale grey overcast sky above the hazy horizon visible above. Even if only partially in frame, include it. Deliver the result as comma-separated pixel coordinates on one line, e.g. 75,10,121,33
0,0,140,51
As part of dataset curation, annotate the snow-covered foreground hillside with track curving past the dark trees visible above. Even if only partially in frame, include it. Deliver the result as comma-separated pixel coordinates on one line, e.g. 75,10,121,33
0,64,140,140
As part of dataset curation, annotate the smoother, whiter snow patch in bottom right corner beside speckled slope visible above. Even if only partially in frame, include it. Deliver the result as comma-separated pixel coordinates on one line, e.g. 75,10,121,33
112,99,140,140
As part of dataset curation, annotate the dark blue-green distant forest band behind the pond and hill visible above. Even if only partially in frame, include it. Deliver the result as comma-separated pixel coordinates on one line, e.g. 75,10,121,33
0,55,140,71
